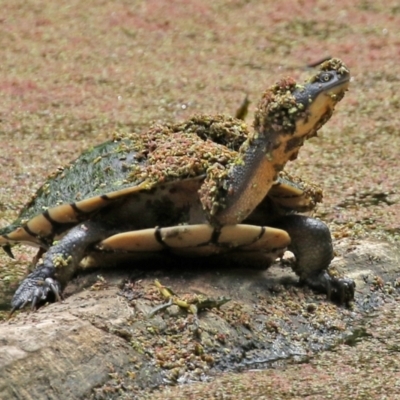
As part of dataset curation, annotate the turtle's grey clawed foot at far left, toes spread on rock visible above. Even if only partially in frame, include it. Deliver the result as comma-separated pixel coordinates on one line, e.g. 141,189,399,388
10,265,61,317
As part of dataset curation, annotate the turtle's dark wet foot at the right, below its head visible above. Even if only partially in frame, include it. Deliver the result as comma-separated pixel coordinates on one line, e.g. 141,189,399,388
302,271,356,305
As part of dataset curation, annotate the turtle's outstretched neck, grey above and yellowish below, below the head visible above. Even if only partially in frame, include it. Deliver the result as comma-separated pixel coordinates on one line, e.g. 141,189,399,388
214,132,302,225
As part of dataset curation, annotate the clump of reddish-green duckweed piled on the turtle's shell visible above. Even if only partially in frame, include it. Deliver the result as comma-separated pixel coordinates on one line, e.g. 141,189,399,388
122,115,249,216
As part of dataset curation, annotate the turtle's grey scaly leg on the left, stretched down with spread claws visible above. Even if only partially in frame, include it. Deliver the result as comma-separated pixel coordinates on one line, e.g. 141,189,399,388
10,221,110,315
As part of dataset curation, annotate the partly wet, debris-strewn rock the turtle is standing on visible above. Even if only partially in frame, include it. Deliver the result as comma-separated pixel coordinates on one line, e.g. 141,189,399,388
0,240,400,399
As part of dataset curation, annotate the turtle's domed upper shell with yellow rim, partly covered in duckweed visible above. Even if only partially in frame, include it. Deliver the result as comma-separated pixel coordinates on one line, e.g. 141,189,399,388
0,115,322,255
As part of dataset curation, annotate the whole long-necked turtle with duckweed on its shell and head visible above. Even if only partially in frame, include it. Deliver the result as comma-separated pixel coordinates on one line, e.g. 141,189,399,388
0,58,355,313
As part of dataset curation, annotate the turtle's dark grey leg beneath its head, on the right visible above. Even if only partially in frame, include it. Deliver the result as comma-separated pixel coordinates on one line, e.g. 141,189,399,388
273,215,355,304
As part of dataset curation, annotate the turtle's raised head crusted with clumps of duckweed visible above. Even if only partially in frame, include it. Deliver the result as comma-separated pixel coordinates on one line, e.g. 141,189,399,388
254,58,350,159
